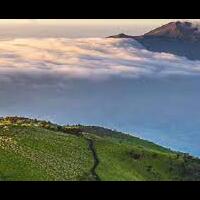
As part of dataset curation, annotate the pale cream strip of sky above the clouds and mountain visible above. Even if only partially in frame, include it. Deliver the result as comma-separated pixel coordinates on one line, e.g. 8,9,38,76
0,19,198,38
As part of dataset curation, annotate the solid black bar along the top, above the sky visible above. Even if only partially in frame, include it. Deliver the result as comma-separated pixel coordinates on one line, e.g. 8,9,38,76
0,0,200,19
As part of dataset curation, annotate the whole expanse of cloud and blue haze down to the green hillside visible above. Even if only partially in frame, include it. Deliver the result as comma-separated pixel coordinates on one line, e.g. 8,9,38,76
0,38,200,156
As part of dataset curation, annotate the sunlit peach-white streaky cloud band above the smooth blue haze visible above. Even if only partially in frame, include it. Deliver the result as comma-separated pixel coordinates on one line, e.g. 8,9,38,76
0,38,200,85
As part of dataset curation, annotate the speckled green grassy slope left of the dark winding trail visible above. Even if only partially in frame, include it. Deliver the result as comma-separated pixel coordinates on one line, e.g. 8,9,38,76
0,120,93,180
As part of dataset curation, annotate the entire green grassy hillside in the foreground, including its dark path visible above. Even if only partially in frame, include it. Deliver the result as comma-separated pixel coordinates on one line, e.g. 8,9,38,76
0,117,200,181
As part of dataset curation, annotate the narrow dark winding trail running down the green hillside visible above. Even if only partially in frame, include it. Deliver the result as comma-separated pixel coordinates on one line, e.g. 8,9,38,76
86,138,101,181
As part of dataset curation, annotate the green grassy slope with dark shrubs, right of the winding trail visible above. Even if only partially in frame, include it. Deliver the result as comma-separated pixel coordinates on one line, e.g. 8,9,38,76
84,127,200,180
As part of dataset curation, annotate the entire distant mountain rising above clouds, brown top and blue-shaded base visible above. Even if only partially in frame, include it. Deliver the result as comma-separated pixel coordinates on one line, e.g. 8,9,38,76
110,21,200,60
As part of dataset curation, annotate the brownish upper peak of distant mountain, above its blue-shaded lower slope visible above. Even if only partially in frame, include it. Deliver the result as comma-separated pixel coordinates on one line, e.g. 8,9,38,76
144,21,200,41
